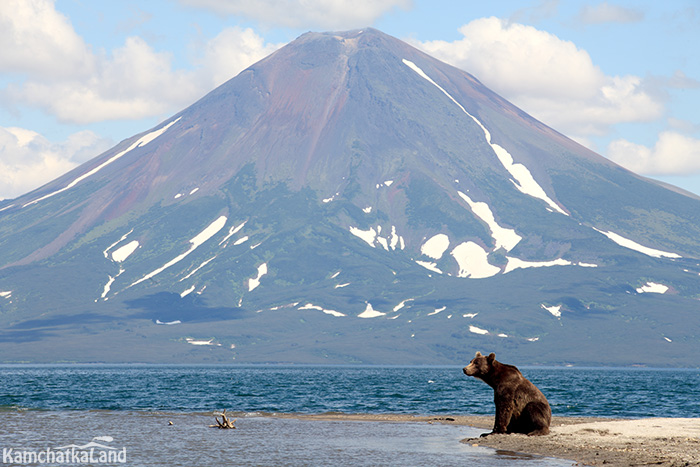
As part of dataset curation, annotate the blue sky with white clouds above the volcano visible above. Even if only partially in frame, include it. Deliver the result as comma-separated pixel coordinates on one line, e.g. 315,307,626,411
0,0,700,198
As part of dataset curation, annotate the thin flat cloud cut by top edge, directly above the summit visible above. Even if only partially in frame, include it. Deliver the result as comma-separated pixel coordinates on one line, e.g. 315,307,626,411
180,0,412,29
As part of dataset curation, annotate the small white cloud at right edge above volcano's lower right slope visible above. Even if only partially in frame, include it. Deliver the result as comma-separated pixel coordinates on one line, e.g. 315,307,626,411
607,131,700,175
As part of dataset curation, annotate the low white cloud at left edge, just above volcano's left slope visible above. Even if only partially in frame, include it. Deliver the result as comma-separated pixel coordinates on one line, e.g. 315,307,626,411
0,127,113,199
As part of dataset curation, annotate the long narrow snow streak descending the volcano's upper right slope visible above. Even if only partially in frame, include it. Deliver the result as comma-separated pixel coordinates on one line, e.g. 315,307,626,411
403,59,569,216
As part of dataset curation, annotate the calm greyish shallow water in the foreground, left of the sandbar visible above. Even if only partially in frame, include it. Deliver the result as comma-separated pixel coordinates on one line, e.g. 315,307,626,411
0,411,571,467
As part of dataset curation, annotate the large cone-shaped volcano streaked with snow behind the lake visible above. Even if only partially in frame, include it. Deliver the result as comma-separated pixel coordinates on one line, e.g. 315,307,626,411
0,29,700,366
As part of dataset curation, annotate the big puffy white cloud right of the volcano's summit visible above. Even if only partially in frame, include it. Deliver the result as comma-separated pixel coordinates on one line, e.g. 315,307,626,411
415,17,663,139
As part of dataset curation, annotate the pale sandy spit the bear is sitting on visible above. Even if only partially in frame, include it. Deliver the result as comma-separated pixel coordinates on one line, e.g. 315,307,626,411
282,413,700,467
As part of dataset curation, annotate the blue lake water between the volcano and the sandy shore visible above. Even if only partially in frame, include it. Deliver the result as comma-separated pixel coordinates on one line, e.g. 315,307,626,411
0,365,700,466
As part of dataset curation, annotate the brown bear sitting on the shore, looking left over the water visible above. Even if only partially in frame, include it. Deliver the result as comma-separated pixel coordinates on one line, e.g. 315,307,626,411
463,352,552,436
